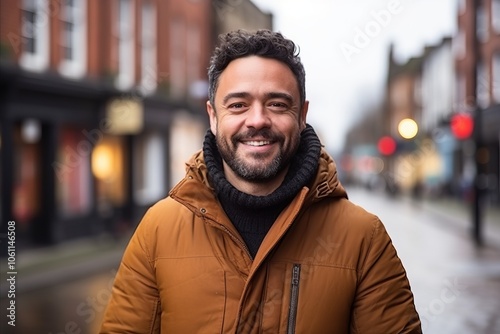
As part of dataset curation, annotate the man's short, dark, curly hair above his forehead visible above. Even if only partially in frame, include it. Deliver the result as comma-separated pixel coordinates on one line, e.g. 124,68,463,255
208,29,306,105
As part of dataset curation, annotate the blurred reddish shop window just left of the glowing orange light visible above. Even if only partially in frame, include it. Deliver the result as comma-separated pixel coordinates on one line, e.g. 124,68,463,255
55,127,92,217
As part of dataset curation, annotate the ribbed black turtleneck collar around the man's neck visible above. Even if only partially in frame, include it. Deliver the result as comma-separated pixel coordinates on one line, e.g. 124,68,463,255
203,124,321,210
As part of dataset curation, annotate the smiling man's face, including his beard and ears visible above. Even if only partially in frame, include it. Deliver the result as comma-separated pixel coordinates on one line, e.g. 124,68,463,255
207,56,308,183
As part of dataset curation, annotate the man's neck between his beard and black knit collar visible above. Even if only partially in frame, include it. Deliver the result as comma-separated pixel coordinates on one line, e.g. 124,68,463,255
223,162,288,196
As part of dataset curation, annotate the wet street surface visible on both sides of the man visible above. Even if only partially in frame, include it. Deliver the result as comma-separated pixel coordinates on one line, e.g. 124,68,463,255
1,188,500,334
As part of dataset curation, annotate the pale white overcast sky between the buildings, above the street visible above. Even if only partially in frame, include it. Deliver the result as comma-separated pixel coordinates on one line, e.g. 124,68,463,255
252,0,457,152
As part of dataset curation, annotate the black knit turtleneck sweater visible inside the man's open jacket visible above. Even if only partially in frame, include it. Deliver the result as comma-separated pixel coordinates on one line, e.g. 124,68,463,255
203,125,321,257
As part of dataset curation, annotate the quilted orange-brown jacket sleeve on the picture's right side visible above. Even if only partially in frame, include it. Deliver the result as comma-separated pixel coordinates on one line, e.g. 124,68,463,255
351,218,422,334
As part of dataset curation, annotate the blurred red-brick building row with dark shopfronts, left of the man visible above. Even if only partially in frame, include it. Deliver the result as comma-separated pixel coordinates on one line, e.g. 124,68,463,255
0,0,272,247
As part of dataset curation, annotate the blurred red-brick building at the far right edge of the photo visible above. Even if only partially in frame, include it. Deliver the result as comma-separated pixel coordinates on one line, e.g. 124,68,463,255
454,0,500,203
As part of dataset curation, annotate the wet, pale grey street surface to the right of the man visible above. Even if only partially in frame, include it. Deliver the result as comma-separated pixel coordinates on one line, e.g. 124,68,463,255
349,188,500,334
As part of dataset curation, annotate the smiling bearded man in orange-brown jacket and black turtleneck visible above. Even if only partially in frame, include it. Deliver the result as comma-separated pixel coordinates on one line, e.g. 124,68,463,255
101,30,421,334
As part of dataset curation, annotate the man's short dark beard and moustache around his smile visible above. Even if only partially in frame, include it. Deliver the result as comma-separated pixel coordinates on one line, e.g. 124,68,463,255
215,129,300,183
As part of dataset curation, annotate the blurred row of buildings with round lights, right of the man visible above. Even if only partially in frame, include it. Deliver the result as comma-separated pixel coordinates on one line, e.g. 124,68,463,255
344,0,500,205
